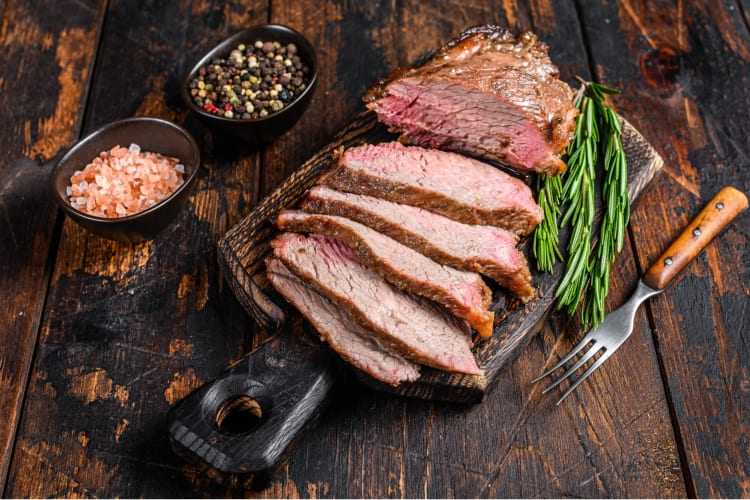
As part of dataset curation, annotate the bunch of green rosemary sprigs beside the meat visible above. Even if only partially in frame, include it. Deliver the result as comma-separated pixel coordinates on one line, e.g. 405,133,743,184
532,82,630,326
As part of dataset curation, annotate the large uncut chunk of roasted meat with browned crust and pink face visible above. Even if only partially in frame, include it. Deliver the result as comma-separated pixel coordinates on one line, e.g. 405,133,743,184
364,26,578,176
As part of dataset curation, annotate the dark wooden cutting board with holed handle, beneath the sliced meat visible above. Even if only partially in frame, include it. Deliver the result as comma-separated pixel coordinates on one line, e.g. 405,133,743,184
168,111,663,487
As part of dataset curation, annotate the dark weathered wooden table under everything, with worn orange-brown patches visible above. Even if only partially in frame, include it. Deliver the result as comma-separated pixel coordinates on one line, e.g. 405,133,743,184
0,0,750,497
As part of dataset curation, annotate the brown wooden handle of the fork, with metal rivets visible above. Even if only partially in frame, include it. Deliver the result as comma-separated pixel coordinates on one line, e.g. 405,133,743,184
643,186,747,290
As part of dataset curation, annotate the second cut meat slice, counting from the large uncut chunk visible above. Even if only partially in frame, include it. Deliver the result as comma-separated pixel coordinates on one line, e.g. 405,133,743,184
300,186,534,302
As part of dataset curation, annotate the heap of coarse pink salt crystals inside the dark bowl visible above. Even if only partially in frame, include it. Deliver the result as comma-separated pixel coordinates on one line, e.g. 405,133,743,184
68,144,185,217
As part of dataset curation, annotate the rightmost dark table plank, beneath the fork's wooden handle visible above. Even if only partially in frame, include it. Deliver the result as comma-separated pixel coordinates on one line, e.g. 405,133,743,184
582,1,750,497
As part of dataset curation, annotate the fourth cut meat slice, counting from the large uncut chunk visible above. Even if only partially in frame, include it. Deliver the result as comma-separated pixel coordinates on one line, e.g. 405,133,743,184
271,233,480,375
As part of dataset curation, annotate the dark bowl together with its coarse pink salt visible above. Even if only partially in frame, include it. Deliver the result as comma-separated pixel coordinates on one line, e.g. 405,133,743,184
50,117,200,243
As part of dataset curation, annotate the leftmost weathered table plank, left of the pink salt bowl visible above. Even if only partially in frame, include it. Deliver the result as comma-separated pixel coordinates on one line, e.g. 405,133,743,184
0,1,104,491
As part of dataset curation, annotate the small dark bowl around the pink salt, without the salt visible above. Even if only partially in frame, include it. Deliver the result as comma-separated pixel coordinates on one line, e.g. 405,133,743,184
50,117,200,243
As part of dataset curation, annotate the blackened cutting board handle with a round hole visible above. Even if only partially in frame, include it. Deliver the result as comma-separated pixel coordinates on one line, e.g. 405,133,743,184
167,327,339,488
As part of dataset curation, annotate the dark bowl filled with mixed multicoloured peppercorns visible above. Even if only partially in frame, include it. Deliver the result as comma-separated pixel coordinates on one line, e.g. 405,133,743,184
187,24,318,144
